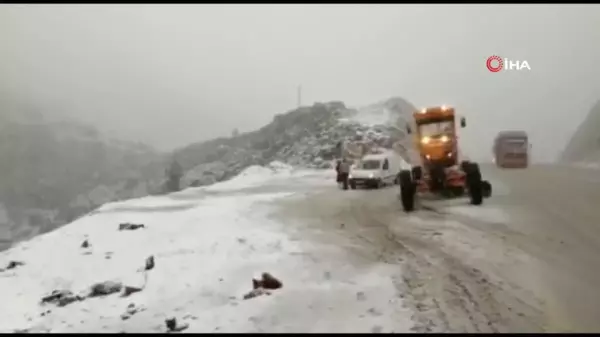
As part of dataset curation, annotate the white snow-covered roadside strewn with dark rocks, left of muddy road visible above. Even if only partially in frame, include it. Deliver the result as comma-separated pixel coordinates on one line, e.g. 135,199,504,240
0,163,412,333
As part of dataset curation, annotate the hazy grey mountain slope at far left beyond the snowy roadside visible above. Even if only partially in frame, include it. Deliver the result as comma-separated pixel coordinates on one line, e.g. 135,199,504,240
0,100,162,249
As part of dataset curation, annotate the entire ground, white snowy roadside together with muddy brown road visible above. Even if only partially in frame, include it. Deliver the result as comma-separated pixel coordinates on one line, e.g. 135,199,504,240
0,161,600,332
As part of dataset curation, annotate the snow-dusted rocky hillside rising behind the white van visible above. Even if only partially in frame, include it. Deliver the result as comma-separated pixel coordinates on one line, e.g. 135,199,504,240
175,98,414,186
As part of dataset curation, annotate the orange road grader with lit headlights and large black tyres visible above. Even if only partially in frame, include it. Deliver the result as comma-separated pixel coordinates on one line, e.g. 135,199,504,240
398,106,492,212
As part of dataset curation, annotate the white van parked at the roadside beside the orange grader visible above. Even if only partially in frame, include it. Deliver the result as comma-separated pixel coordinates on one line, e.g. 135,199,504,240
348,151,404,189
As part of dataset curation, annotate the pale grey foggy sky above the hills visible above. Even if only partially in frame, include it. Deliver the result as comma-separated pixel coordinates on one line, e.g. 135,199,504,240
0,5,600,161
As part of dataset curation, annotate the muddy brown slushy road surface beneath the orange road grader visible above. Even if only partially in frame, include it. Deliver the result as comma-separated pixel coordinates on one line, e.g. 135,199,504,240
282,162,600,332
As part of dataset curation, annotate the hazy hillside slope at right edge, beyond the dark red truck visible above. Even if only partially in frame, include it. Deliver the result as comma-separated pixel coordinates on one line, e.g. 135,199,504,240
560,101,600,165
